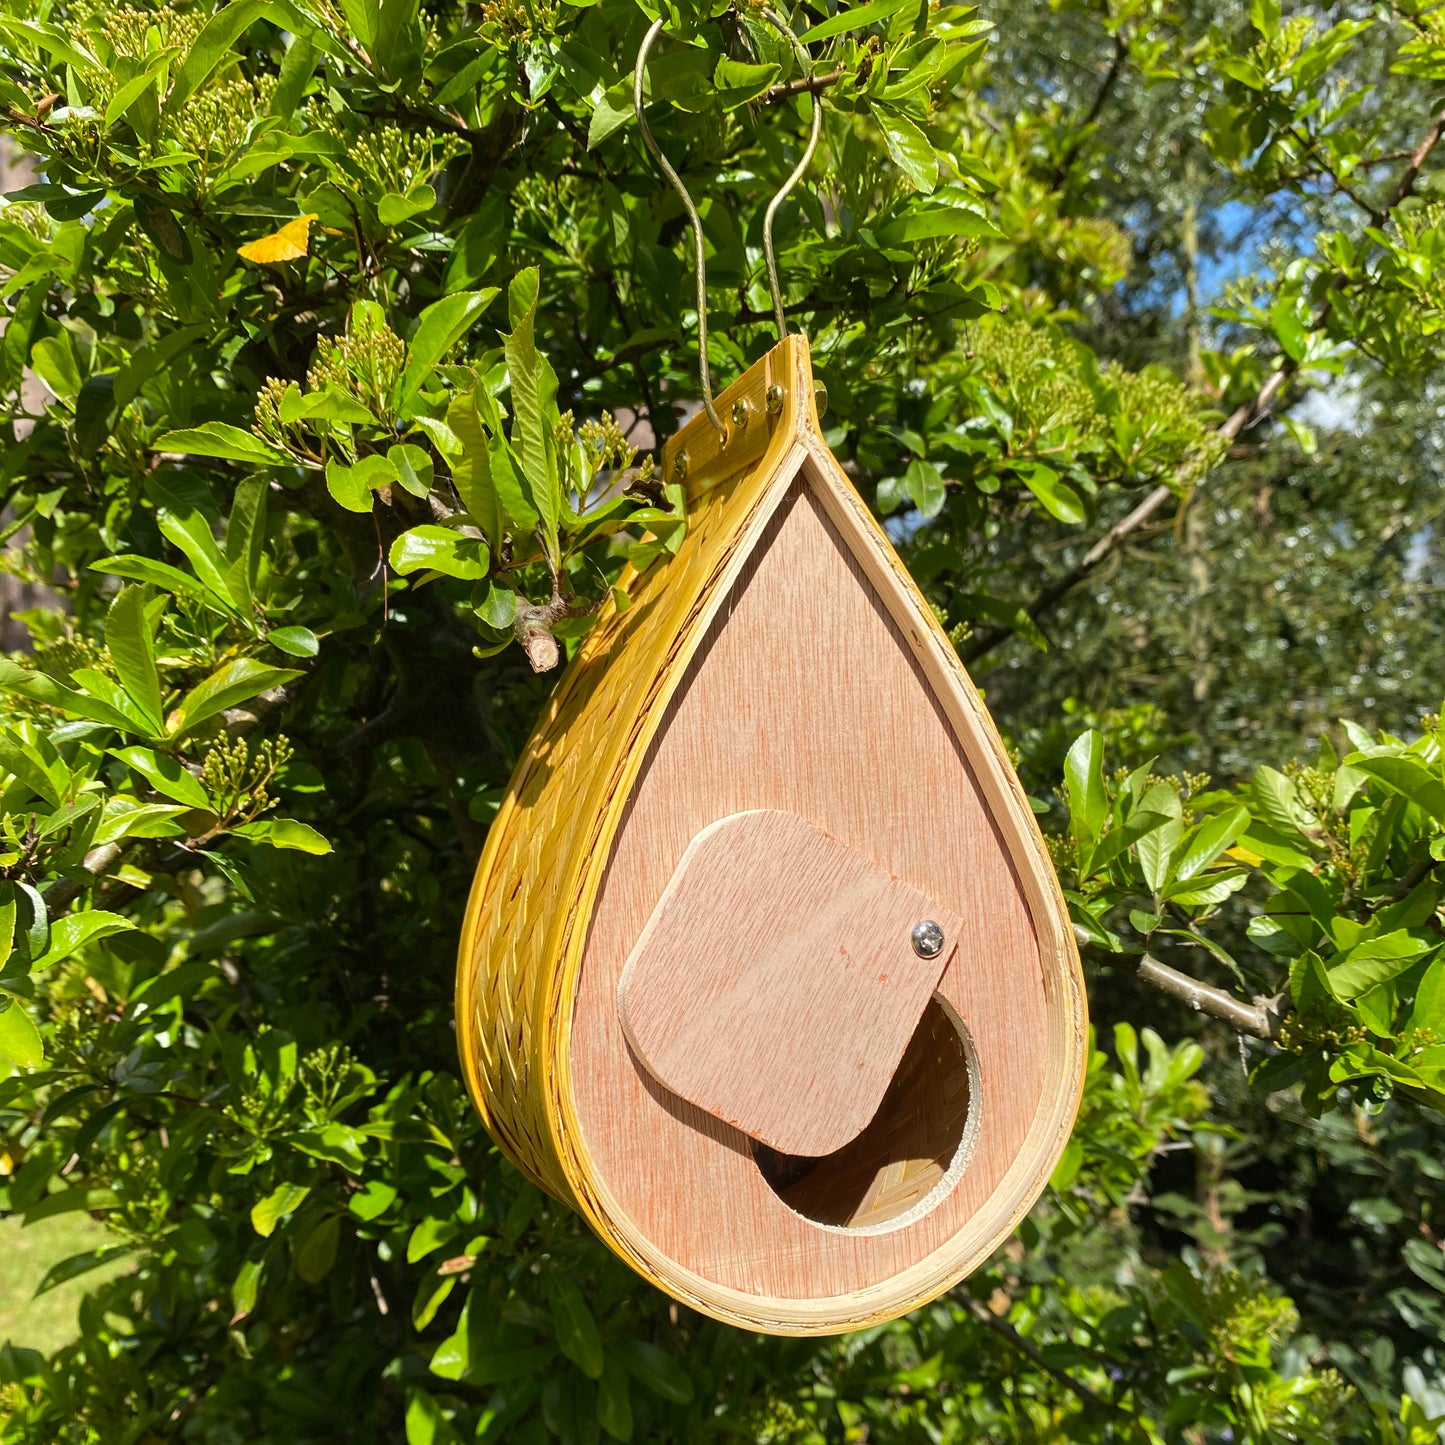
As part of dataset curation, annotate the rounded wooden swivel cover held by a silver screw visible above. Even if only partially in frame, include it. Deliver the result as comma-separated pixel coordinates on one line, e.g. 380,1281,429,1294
617,809,962,1156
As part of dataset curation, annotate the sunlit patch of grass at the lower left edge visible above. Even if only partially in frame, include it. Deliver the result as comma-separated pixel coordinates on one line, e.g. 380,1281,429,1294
0,1211,134,1354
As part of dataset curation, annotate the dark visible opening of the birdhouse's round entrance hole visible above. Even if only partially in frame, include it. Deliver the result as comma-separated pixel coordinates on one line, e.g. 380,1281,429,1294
753,998,970,1230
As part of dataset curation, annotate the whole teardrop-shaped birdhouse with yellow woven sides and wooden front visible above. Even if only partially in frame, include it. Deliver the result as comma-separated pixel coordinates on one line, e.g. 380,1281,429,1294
458,337,1087,1334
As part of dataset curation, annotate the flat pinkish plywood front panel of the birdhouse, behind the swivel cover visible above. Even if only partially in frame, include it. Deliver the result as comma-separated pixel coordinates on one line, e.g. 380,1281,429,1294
571,468,1052,1301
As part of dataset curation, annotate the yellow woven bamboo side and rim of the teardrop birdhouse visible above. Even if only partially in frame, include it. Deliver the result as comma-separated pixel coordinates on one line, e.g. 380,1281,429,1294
457,337,1087,1334
